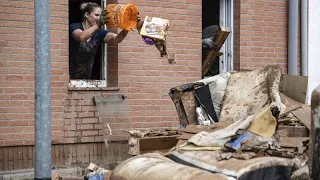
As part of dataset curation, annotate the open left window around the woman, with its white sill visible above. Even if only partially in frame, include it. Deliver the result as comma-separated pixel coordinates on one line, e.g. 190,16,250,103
69,0,108,87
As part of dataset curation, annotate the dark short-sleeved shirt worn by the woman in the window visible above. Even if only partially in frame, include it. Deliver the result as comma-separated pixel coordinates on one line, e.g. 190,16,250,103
69,23,108,79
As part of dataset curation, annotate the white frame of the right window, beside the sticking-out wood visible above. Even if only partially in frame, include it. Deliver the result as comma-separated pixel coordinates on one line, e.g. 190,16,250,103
219,0,233,73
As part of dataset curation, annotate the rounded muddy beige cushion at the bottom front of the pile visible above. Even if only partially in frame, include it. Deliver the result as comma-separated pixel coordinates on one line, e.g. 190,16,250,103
110,153,234,180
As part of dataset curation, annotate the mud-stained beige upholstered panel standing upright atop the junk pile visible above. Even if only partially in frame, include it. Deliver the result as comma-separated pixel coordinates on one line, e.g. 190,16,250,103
219,66,284,122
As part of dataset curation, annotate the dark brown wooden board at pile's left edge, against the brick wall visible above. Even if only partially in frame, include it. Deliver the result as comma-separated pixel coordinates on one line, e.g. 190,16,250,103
138,136,178,154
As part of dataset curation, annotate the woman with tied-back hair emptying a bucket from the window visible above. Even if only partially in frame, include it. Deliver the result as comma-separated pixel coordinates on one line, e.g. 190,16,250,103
69,2,128,79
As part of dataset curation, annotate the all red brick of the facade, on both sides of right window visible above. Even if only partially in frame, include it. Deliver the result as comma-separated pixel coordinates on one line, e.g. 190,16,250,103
0,0,288,150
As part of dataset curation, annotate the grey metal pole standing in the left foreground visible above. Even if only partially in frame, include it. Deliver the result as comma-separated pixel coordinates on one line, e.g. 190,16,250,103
34,0,51,179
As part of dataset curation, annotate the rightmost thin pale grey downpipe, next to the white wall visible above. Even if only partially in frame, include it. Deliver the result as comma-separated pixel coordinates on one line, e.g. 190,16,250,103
301,0,308,76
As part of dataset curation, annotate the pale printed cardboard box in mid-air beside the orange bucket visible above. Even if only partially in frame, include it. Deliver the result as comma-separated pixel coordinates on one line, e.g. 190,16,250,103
140,16,170,40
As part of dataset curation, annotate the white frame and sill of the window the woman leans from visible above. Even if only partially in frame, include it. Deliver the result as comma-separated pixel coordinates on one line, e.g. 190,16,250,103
69,0,108,88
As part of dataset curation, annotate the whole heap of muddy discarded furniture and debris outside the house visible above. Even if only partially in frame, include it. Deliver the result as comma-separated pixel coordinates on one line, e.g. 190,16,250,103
90,65,311,180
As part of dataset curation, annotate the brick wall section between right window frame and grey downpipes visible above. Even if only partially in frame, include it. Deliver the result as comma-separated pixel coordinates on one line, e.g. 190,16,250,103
234,0,288,73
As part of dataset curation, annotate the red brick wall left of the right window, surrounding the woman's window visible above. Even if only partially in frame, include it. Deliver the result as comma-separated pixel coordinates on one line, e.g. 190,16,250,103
0,0,201,146
